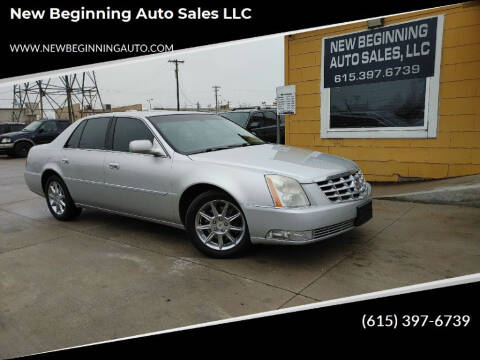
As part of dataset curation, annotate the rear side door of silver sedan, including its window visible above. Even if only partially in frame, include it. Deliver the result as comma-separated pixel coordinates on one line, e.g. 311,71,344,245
58,117,111,208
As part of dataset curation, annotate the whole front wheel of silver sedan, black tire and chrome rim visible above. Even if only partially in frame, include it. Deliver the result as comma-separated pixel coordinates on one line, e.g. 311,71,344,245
185,191,250,258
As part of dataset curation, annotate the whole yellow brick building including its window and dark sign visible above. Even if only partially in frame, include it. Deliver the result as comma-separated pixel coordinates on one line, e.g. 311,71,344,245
285,1,480,181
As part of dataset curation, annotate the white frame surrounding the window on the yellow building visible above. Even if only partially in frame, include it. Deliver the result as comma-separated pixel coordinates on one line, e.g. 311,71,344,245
320,14,445,139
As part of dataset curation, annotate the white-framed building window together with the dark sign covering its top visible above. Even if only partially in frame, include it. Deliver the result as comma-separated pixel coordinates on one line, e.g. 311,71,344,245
320,16,444,138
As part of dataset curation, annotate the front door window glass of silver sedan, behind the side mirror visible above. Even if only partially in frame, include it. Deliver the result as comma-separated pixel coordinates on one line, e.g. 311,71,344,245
113,118,153,152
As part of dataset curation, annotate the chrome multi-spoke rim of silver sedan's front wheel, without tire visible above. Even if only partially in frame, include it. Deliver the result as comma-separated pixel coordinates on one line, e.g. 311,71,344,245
195,200,246,250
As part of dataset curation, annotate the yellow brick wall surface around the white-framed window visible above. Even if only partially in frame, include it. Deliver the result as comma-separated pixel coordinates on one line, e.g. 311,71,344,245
285,1,480,181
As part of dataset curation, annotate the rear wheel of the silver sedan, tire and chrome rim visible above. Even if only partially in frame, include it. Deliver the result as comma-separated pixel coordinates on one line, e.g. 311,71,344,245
44,175,82,221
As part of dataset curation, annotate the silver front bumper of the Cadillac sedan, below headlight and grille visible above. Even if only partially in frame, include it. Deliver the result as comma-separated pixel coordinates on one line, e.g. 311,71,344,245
244,186,372,245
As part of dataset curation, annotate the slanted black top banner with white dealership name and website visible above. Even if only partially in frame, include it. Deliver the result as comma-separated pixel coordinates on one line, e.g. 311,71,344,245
0,0,455,79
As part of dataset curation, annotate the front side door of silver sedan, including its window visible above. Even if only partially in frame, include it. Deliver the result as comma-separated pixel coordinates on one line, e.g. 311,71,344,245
105,117,174,220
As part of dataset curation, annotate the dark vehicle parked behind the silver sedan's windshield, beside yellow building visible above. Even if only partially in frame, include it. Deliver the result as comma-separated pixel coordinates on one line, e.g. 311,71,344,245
218,109,285,144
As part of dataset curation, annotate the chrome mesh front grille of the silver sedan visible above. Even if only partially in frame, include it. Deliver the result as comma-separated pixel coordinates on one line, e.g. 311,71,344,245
317,170,367,202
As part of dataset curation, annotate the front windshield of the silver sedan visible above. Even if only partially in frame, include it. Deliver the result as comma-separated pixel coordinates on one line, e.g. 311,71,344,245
148,114,264,155
